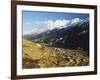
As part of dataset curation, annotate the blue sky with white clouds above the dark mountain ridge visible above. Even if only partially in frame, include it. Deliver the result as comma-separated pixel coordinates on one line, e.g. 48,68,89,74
22,11,89,33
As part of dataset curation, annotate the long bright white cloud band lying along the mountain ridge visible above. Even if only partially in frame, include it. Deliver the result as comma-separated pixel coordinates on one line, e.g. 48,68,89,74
23,18,82,35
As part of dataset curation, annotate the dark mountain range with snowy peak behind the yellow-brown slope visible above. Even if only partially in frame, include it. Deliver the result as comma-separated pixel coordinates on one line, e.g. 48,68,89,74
23,18,89,53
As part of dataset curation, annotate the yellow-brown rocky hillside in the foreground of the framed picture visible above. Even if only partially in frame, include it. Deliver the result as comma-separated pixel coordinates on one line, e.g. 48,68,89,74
22,39,89,68
